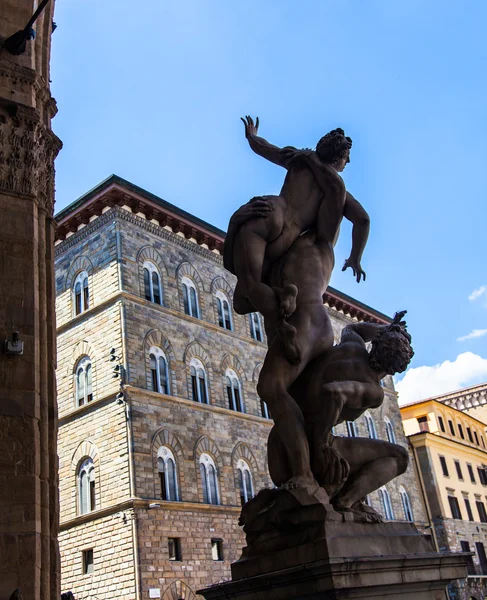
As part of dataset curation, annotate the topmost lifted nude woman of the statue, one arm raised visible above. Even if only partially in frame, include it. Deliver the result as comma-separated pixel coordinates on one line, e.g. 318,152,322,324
224,117,368,363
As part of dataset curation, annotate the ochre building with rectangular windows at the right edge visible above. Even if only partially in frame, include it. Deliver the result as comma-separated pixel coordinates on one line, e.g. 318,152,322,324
401,394,487,600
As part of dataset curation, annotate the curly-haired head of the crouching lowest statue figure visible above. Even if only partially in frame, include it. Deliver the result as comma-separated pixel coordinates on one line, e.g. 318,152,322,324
369,324,414,375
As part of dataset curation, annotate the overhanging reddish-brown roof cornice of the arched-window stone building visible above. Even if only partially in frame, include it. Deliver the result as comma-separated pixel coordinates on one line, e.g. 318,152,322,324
54,175,392,323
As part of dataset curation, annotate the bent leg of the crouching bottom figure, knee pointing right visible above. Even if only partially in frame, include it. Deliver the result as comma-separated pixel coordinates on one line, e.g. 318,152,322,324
332,437,409,509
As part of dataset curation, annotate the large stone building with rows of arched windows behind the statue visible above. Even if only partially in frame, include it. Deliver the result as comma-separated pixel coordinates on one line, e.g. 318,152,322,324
56,176,426,600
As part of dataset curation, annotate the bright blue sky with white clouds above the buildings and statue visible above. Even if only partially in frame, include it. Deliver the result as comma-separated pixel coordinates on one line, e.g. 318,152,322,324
51,0,487,401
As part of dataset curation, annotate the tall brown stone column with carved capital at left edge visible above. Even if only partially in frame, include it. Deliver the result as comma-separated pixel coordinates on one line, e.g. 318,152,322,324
0,0,61,600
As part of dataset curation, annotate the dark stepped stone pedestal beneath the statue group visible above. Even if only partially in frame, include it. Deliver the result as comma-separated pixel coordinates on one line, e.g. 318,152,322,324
198,522,467,600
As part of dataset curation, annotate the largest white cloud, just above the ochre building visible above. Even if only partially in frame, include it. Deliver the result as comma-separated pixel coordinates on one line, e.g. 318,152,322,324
396,352,487,405
